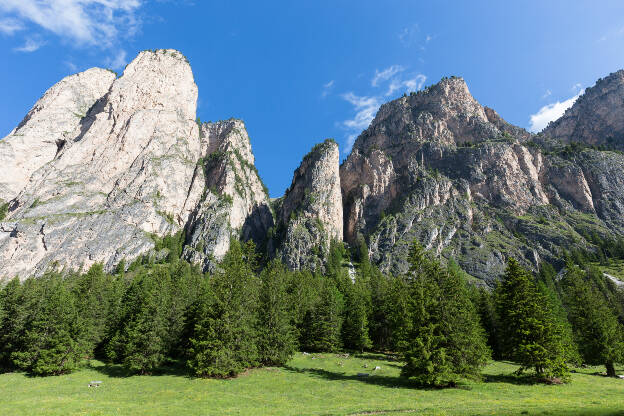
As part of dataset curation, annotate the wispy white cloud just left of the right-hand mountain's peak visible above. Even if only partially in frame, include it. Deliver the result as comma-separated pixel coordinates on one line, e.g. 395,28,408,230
340,65,427,154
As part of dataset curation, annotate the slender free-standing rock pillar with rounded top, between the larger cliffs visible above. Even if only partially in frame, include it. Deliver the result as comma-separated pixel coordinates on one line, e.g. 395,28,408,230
277,140,343,270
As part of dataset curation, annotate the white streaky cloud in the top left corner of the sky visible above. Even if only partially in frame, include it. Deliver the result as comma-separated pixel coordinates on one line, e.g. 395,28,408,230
0,0,142,47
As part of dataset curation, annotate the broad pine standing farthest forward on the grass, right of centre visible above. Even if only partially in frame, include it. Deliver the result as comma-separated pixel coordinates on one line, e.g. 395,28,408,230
401,242,489,385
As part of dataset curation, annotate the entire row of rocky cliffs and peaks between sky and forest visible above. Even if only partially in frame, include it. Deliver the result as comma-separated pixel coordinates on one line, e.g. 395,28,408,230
0,50,624,282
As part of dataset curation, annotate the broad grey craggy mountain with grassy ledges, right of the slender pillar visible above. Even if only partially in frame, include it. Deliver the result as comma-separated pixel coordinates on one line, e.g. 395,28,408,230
340,78,624,280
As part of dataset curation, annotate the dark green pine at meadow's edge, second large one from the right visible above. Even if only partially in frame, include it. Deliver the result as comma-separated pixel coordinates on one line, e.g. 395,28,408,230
496,259,568,378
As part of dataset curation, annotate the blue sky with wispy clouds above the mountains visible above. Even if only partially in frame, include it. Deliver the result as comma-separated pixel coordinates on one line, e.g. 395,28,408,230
0,0,624,197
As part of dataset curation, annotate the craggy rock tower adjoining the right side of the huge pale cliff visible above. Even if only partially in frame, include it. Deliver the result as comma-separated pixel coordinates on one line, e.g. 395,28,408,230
184,120,273,270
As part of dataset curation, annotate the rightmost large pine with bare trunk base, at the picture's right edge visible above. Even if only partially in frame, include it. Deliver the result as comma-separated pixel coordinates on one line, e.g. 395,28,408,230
564,264,624,377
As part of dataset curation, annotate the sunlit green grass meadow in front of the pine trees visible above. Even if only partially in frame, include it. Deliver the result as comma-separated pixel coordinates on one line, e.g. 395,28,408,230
0,354,624,415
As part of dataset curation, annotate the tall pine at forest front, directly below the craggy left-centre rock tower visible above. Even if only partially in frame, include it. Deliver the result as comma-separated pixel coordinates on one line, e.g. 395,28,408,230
188,240,260,377
